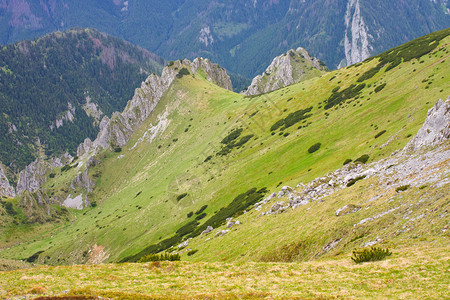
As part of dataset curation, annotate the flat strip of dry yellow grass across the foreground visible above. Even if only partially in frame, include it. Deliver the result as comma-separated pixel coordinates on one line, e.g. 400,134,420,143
0,240,450,299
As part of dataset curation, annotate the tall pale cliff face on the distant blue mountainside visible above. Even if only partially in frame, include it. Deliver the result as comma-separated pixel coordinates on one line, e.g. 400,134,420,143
344,0,373,65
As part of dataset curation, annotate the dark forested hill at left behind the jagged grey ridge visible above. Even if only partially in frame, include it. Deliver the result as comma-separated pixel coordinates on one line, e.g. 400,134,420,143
0,29,164,176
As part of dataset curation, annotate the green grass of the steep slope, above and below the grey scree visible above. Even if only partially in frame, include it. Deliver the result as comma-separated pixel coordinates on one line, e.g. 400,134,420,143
0,30,450,264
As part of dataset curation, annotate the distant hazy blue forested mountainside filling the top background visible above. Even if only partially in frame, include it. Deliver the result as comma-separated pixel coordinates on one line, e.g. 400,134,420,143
0,0,450,78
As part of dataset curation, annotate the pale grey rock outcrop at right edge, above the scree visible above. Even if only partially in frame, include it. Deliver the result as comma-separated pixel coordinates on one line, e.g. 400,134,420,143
405,97,450,151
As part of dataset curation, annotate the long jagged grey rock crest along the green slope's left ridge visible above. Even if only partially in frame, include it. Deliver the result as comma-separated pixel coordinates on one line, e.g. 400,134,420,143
77,58,232,156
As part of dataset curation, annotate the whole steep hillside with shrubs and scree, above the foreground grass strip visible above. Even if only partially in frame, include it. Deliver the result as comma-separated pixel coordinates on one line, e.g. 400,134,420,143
0,30,450,264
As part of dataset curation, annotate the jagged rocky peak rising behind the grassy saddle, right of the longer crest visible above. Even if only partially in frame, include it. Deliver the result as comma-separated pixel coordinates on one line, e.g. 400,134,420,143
244,47,326,95
